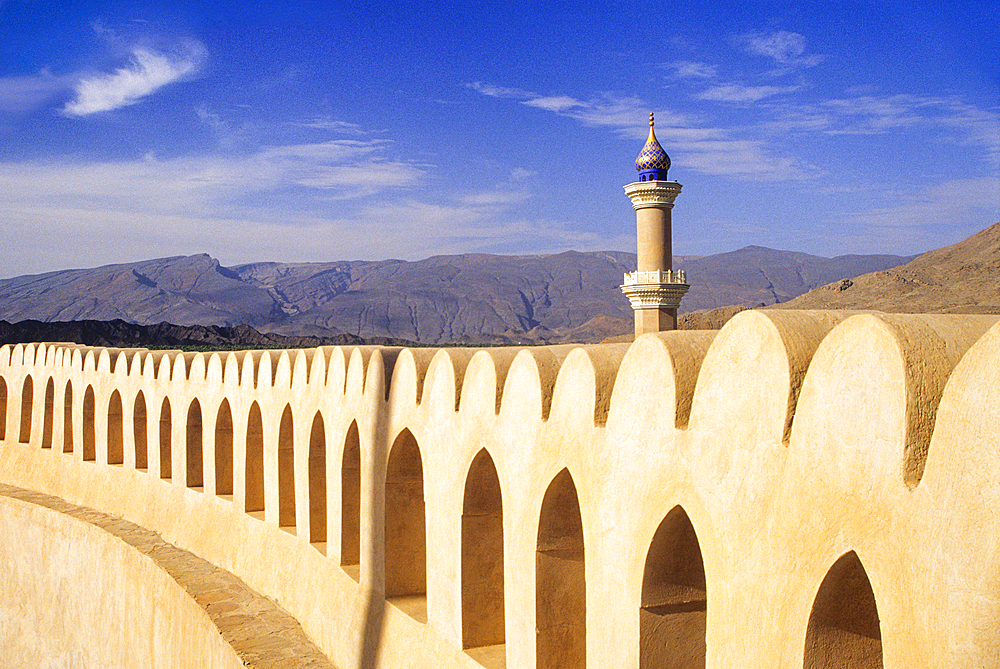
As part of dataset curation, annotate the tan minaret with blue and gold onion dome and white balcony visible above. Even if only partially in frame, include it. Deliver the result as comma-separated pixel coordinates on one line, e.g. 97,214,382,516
622,114,690,337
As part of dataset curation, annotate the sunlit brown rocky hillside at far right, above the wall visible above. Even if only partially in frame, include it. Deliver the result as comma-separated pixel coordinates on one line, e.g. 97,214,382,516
781,223,1000,314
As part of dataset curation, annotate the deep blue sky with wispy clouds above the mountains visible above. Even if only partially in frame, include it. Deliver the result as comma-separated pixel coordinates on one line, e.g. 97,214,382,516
0,0,1000,276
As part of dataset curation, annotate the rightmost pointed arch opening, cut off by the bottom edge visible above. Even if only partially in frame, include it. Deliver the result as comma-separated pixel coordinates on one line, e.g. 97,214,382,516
803,551,882,669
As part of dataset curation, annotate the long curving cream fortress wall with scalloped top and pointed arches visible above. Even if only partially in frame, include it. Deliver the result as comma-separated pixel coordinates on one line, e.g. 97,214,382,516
0,311,1000,668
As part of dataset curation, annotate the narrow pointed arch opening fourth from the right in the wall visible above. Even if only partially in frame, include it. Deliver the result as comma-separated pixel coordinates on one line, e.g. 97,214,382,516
462,448,505,648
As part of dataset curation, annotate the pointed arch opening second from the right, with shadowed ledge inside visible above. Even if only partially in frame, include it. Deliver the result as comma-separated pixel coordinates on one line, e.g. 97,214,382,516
639,506,708,669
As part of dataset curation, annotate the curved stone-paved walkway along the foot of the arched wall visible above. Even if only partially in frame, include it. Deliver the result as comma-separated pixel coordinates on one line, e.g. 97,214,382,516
0,484,334,669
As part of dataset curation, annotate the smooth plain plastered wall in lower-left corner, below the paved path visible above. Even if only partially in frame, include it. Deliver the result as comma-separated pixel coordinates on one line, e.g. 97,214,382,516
0,488,244,669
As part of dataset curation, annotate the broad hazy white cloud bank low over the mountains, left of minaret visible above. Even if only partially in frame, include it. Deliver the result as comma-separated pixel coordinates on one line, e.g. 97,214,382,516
0,139,613,276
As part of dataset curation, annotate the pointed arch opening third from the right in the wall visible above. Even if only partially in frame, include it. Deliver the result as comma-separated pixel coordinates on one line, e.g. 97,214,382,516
535,469,587,669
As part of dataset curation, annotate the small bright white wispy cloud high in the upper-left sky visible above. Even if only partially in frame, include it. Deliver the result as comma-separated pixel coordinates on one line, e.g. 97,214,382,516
63,42,206,116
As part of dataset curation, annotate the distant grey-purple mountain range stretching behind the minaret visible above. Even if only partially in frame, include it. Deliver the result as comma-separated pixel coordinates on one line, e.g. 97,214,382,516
0,246,910,344
